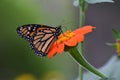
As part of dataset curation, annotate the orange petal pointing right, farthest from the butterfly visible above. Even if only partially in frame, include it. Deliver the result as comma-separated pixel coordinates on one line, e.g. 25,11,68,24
74,25,95,34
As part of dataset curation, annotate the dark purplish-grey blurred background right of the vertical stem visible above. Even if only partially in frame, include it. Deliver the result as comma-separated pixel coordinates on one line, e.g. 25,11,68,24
85,0,120,67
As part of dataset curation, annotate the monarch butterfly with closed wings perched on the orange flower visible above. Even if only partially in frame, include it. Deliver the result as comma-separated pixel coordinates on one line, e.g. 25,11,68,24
17,24,62,56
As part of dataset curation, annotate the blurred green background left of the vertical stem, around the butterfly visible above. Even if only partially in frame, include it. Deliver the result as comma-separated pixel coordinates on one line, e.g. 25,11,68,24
0,0,77,80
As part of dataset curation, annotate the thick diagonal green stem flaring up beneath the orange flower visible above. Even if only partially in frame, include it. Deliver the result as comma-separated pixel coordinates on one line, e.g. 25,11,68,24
69,47,107,78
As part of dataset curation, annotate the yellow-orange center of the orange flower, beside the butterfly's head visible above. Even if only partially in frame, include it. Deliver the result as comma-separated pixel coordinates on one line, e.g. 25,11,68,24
57,31,75,43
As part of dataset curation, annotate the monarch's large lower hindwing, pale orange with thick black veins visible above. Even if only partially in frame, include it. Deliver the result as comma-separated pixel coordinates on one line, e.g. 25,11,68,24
30,27,58,56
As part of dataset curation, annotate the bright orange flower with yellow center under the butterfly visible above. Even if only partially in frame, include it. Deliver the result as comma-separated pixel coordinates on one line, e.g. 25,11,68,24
48,26,95,58
